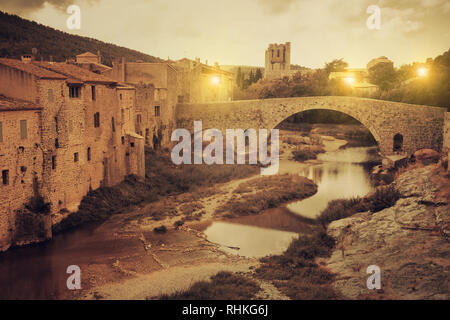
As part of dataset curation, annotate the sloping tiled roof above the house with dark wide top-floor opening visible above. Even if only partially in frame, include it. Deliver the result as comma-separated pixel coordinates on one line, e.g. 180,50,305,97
33,61,116,84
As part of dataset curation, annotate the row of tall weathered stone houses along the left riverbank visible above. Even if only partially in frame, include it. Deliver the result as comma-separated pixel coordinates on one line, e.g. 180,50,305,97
0,59,145,249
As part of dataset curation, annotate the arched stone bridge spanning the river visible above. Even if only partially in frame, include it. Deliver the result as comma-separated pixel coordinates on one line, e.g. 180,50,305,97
176,96,446,155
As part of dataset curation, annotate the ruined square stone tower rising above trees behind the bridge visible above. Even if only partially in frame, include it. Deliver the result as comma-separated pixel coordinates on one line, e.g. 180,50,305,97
264,42,291,79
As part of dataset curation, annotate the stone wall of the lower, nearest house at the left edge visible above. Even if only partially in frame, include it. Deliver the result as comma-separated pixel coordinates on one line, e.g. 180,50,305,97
0,110,42,251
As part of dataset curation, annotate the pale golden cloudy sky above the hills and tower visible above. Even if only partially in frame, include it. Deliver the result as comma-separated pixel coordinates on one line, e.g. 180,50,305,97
0,0,450,68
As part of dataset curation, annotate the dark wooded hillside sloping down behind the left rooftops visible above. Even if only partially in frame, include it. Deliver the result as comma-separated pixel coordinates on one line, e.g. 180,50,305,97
0,11,162,66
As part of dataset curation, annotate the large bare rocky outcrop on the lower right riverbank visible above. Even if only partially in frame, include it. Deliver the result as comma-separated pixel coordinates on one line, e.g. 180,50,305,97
322,164,450,299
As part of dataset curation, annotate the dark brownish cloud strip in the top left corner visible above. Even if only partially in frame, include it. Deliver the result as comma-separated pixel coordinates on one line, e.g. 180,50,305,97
0,0,98,13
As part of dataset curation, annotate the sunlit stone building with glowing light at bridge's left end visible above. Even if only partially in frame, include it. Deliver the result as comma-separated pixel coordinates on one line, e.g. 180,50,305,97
172,58,234,103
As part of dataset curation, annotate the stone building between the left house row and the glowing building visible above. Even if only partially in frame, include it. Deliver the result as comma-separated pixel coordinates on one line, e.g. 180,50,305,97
103,58,177,149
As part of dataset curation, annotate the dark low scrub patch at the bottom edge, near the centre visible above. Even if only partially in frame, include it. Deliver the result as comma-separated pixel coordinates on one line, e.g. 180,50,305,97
159,271,261,300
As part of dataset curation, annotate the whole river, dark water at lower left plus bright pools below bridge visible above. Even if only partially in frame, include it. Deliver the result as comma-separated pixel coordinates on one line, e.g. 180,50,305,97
0,140,375,299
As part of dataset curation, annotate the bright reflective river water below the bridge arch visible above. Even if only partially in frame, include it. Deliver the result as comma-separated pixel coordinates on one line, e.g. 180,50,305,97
204,139,379,257
